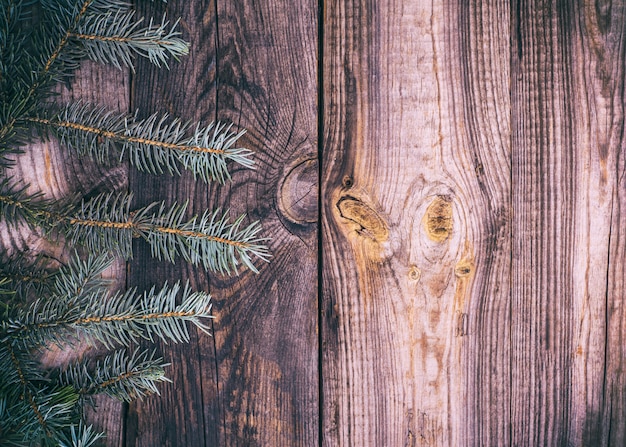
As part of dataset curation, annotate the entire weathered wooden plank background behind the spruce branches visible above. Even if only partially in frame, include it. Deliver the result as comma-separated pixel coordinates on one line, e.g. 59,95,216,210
8,0,626,447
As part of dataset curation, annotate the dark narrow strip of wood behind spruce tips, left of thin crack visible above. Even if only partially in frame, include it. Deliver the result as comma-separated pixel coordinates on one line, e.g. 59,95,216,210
125,0,220,447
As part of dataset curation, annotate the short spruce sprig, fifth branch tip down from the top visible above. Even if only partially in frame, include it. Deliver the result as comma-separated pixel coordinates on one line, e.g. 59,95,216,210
60,350,170,402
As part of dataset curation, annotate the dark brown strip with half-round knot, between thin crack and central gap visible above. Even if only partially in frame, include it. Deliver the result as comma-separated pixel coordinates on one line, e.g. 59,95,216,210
212,0,319,446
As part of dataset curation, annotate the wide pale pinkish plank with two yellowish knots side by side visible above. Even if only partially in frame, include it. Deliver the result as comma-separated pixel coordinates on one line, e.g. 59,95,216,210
322,0,510,446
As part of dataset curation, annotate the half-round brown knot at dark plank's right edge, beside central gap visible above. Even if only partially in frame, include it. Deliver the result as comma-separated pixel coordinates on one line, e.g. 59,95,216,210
278,159,318,225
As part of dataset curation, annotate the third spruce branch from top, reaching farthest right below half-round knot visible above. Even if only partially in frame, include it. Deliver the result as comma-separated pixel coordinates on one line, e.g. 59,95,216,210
0,185,270,274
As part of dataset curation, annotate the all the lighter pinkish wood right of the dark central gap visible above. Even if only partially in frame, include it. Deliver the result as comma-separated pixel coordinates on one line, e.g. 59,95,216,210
321,0,626,446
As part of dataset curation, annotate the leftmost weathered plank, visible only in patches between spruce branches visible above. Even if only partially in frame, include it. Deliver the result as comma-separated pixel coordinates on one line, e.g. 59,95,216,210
0,57,130,445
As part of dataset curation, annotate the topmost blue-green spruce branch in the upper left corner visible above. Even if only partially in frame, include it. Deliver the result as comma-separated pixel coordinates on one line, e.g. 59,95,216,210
0,0,189,158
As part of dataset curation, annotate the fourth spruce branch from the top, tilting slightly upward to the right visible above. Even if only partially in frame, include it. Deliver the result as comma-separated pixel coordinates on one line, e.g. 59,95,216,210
0,283,212,347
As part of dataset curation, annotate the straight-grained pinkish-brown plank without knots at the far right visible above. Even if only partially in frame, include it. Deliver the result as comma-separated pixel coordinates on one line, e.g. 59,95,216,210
511,1,626,445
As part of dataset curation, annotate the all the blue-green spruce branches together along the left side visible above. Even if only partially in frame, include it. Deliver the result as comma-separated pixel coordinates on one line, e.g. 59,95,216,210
0,0,270,447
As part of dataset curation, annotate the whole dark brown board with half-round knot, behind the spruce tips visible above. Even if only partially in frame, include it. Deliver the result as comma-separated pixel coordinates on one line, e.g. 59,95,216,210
126,0,318,446
